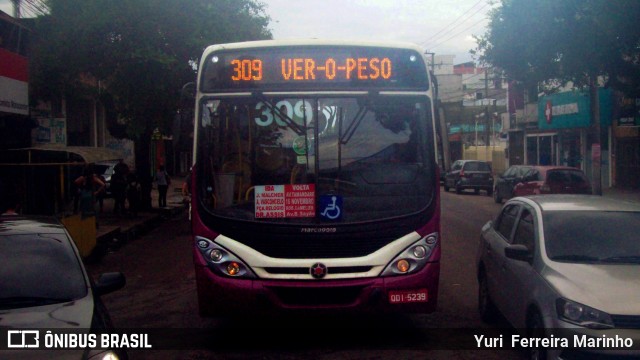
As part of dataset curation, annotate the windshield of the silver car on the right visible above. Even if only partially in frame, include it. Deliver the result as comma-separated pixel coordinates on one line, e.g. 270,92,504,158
543,211,640,264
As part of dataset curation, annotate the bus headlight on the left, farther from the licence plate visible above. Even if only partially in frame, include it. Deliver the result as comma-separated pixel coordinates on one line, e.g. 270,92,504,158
196,236,256,279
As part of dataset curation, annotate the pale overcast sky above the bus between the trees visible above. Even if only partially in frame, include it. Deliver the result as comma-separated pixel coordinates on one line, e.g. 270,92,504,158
0,0,491,64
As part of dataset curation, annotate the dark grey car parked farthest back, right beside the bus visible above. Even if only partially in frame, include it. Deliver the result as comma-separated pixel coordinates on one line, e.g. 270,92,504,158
444,160,493,196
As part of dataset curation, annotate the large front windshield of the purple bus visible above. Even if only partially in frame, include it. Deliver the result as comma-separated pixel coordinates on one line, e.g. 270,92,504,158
197,93,436,224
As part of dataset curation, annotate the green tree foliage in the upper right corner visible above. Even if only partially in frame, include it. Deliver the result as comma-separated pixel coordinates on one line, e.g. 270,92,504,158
472,0,640,94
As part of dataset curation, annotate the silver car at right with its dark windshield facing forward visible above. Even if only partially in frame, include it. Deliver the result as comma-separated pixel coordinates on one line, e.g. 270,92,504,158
477,195,640,359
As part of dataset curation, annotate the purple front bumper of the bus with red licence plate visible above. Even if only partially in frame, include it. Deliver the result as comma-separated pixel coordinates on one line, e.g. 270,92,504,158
195,262,440,316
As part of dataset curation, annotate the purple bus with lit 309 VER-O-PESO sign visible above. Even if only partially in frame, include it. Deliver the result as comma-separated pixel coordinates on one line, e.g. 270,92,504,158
190,40,441,316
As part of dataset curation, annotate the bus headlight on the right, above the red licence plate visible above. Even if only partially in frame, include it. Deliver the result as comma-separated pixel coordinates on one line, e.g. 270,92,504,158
382,233,438,276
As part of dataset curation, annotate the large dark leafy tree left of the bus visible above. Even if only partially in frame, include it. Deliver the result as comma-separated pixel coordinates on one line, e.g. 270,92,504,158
31,0,271,206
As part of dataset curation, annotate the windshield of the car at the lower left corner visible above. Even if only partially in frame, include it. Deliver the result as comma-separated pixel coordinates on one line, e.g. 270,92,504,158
0,234,88,309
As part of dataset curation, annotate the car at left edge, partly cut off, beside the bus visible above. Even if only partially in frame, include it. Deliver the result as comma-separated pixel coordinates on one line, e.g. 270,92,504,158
0,215,127,360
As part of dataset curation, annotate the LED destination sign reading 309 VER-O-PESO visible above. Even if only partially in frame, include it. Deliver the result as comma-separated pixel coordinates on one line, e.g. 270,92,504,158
201,47,428,91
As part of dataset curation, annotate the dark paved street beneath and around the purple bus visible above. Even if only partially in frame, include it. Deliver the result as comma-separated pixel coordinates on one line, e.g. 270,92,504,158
89,188,524,359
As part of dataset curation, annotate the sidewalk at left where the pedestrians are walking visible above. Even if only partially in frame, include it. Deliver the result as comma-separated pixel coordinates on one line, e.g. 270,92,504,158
94,177,186,257
